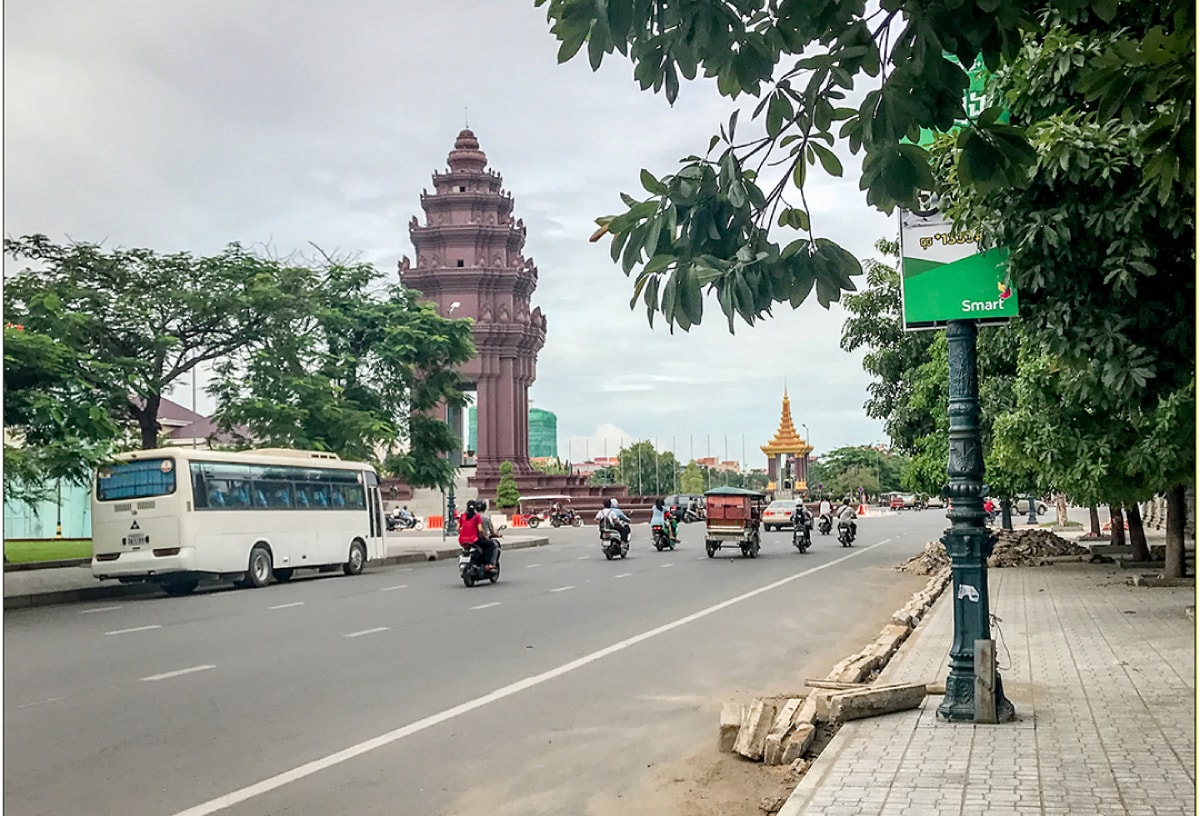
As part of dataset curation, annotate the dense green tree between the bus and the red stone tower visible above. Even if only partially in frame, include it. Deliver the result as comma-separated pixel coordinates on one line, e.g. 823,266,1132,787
212,258,474,487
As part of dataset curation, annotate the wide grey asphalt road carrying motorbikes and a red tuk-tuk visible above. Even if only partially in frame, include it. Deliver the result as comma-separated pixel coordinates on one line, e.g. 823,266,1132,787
4,511,947,816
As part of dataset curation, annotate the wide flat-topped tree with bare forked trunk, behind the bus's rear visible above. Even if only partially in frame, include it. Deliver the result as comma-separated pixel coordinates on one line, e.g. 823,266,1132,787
4,235,307,448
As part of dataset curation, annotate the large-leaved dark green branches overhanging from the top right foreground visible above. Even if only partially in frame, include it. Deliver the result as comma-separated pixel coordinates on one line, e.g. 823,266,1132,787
535,0,1180,331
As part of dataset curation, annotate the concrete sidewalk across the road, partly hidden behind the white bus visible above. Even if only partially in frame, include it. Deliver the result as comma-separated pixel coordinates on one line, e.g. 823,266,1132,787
4,530,550,610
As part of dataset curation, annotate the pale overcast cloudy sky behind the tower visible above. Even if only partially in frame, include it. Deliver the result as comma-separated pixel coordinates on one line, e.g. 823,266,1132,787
4,0,896,467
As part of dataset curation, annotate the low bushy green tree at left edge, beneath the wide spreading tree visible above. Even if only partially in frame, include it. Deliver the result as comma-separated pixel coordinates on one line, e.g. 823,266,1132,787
4,324,120,500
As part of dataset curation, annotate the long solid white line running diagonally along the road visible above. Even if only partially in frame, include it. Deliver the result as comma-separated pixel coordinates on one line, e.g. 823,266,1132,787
174,544,881,816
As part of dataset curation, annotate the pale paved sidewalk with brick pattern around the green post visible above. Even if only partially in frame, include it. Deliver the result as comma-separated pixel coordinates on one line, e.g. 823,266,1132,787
779,563,1196,816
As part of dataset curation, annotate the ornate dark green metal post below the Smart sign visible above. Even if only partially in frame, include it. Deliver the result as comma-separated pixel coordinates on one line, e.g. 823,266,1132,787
937,320,1015,722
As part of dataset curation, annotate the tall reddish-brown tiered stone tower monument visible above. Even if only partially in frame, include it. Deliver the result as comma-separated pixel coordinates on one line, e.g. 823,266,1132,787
400,130,546,491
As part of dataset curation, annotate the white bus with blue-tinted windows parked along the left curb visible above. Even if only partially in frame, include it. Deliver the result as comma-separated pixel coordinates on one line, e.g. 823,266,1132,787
91,448,385,595
